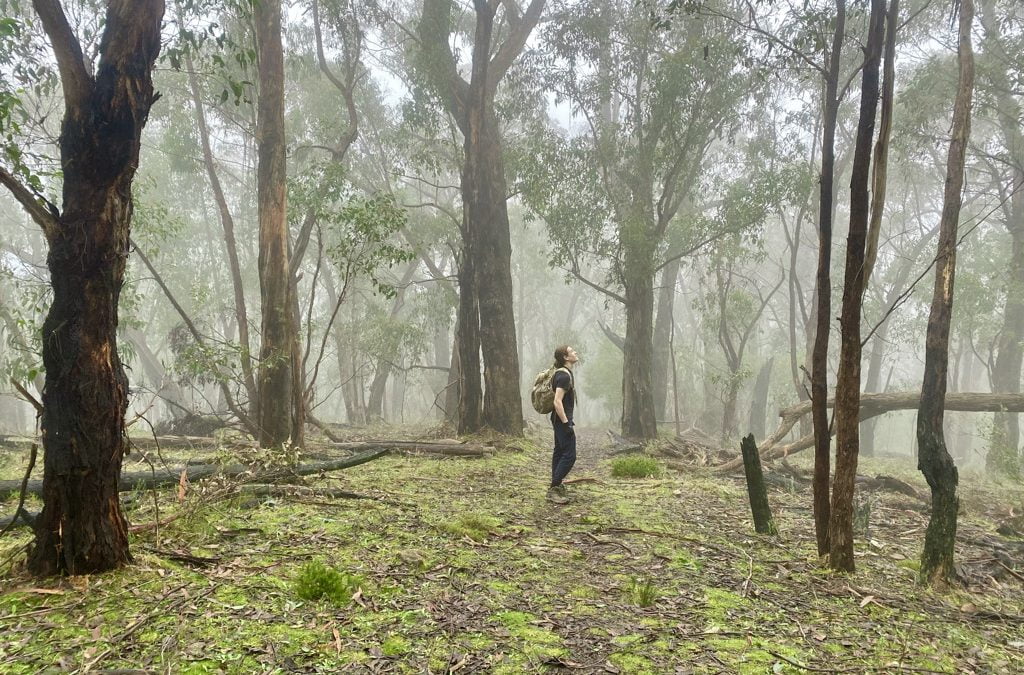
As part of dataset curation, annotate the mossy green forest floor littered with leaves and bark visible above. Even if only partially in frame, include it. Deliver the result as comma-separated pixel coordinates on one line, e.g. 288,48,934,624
0,428,1024,673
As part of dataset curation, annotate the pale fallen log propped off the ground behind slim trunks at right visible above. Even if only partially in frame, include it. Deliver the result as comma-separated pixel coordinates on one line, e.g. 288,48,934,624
715,391,1024,473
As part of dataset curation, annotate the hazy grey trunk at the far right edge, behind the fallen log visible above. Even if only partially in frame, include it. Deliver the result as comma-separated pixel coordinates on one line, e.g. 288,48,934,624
981,0,1024,475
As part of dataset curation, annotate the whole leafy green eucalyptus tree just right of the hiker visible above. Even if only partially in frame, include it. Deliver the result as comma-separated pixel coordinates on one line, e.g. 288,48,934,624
526,0,756,438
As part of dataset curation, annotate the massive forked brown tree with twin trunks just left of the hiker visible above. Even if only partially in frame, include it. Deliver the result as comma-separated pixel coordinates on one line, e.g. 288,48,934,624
418,0,545,435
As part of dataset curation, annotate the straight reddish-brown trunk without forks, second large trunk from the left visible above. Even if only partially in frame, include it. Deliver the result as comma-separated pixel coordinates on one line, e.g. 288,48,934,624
253,0,295,448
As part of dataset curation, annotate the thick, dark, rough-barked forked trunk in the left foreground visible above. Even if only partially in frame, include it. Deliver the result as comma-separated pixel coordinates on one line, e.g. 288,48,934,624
23,0,164,576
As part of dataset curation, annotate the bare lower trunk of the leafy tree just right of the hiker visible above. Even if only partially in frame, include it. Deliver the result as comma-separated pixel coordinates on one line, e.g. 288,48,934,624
622,241,657,438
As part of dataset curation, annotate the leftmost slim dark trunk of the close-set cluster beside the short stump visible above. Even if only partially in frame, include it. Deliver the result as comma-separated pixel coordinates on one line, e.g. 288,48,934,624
811,0,846,555
